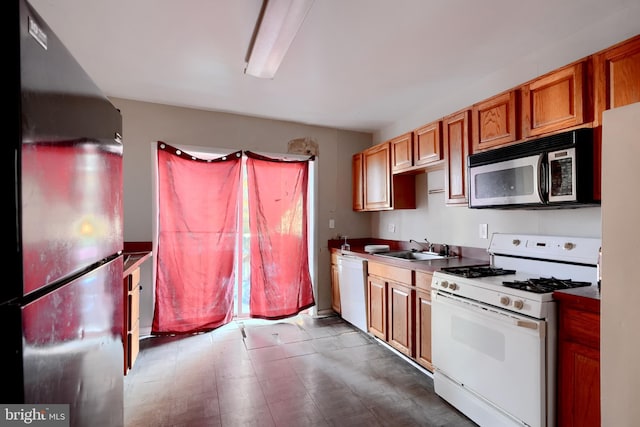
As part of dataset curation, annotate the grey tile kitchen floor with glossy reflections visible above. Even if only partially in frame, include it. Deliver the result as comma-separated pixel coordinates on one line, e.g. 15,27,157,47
124,315,476,427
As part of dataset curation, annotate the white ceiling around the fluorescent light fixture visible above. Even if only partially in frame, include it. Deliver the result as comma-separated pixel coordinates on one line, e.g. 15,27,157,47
30,0,640,133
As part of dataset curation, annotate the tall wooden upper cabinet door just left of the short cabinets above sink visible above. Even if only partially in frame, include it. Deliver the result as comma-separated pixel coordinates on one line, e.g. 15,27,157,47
362,142,391,210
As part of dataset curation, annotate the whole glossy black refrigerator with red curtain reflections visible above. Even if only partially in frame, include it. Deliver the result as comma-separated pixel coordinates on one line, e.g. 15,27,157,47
0,0,124,426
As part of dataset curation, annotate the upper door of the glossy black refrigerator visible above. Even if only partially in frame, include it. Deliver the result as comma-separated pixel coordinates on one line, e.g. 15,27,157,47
15,1,123,302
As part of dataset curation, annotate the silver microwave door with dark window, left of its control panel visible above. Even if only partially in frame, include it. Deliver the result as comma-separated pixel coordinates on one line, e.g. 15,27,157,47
470,155,543,207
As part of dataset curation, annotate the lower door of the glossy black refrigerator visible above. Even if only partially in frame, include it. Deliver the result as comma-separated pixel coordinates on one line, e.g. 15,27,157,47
0,256,124,426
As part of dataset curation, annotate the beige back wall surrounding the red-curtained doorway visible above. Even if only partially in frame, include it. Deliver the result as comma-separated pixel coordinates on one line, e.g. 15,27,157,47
111,98,371,333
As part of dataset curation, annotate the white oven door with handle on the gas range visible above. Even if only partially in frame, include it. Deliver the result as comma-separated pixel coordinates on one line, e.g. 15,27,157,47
432,294,546,426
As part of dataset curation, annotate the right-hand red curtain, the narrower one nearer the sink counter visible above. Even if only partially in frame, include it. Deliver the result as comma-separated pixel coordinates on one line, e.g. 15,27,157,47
245,152,315,319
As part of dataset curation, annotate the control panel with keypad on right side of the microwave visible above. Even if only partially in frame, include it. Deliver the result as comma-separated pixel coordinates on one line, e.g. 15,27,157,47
549,148,576,202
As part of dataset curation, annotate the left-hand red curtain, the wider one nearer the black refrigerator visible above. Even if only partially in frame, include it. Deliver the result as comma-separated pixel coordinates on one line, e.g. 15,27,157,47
151,142,242,334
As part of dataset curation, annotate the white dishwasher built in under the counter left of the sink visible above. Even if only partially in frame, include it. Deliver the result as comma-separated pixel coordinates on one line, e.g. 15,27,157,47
338,254,368,332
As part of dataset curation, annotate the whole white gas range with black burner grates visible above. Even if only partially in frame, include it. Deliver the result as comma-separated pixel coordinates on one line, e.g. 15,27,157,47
431,234,600,427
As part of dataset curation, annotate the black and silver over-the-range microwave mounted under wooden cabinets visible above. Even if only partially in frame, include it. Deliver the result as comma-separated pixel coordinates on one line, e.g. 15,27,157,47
467,128,599,209
